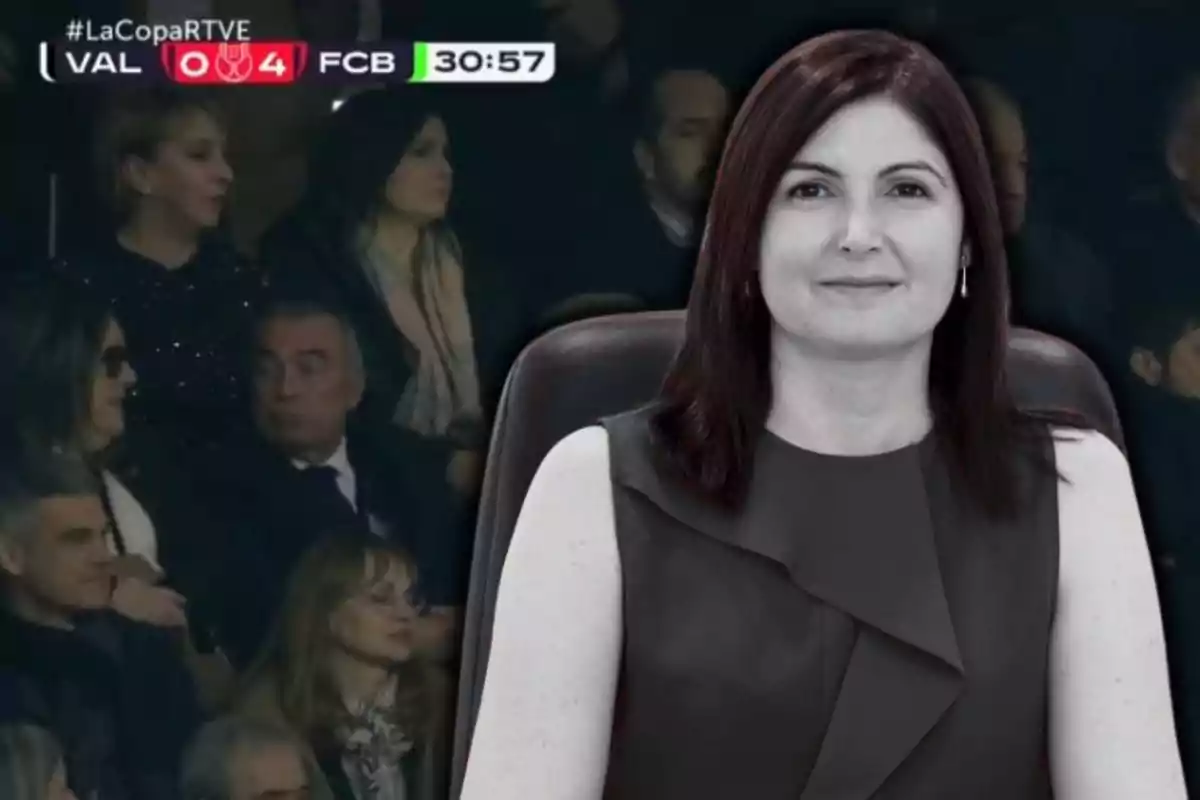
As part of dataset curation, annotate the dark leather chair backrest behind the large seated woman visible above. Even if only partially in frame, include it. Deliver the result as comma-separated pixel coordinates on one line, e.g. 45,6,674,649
451,311,1123,796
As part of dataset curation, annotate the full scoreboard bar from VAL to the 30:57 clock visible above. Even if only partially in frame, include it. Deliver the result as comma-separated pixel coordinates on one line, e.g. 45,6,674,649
38,42,554,85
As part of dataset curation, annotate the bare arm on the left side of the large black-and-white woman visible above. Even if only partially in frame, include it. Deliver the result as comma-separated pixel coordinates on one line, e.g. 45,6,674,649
462,427,622,800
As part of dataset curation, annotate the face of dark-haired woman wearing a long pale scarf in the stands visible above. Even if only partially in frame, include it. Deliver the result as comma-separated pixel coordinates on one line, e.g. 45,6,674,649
384,116,454,224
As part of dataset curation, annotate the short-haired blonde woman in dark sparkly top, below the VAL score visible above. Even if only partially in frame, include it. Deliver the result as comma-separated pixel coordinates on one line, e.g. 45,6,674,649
67,88,258,451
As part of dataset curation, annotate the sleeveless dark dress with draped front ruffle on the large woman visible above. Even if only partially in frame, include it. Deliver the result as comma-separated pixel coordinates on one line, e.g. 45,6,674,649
604,409,1058,800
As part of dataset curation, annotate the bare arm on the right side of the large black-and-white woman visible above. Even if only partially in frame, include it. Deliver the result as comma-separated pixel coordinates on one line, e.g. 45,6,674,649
1050,432,1187,800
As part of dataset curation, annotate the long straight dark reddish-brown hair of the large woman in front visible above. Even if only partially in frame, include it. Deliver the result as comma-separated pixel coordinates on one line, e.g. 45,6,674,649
654,30,1024,515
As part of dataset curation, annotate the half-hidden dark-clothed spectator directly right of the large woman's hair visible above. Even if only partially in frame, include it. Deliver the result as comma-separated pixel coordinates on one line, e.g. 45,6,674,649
967,79,1116,374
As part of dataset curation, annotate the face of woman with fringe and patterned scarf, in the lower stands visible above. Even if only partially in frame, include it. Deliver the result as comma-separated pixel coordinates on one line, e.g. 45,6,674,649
330,554,416,667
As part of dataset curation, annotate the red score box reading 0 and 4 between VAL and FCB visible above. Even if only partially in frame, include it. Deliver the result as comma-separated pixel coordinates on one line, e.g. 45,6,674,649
160,42,308,85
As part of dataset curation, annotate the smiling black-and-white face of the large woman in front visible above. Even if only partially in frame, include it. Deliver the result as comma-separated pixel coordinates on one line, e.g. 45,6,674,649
760,97,964,360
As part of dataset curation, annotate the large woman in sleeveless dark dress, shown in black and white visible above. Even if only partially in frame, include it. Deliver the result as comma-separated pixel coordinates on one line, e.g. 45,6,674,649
462,31,1187,800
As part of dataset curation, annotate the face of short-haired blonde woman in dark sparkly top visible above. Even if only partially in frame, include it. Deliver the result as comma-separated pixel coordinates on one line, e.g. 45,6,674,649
126,110,233,230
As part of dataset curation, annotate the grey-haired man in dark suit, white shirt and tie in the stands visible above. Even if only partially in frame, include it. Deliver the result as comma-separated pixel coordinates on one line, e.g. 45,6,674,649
212,297,460,661
